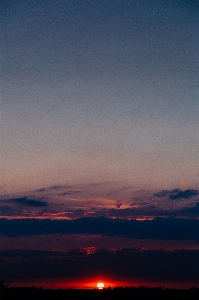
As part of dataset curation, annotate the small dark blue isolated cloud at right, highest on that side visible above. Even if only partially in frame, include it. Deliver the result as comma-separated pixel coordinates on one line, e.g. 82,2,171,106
153,189,199,200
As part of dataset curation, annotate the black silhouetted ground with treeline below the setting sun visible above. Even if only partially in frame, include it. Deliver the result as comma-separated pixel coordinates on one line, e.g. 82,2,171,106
0,287,199,300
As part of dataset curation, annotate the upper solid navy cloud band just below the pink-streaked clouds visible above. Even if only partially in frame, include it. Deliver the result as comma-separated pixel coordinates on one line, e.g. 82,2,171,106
0,217,199,240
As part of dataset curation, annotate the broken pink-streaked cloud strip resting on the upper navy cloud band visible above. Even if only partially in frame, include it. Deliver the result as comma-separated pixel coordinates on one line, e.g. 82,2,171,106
0,202,199,219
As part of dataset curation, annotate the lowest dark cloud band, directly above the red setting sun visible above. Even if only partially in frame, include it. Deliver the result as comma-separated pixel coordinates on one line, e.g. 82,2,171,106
0,248,199,281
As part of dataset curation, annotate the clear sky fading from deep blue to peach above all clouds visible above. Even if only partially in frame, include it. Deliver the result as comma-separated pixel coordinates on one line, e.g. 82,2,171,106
1,0,199,194
